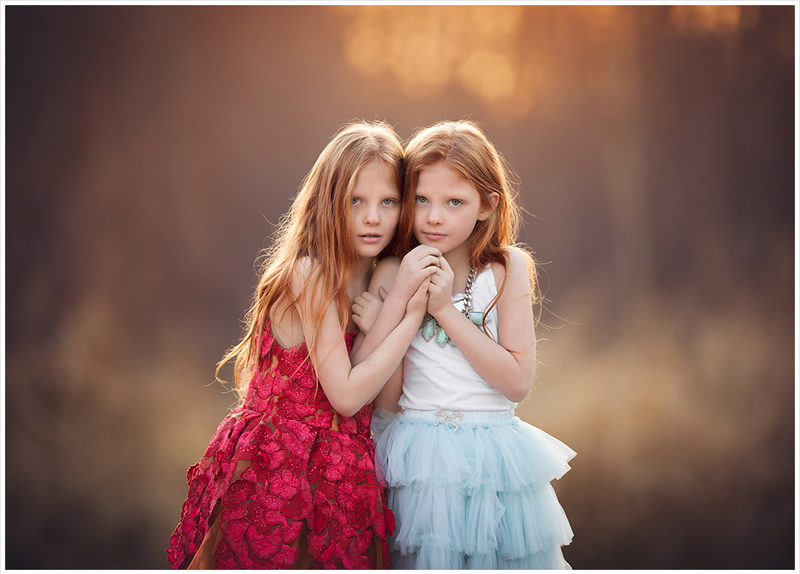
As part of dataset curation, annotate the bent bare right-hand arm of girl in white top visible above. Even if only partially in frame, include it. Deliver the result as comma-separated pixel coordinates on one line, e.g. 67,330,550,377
428,249,536,402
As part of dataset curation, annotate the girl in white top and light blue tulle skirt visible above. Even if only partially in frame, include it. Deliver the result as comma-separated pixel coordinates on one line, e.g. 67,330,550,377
352,121,575,569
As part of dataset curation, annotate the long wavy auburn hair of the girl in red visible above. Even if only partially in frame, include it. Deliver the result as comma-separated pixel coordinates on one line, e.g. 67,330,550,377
216,121,403,398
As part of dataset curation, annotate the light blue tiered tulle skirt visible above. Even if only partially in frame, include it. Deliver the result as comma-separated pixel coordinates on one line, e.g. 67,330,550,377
372,409,575,570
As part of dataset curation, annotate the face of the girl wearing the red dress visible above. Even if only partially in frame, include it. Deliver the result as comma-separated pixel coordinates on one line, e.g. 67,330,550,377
350,158,400,257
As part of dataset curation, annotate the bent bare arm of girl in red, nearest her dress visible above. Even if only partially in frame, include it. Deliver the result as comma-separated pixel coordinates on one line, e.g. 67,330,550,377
292,259,432,416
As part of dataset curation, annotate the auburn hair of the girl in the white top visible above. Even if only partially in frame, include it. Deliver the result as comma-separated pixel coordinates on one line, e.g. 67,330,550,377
398,120,538,308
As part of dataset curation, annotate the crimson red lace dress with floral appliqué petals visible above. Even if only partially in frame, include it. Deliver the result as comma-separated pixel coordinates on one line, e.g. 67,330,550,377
167,323,394,569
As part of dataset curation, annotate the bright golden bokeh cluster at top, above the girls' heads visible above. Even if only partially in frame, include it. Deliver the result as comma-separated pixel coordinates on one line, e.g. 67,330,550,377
332,6,532,110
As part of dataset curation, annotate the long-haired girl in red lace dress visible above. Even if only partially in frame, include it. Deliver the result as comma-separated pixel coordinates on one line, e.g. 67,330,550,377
167,122,436,569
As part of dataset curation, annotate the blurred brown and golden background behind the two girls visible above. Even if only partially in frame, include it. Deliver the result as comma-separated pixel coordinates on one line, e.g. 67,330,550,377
3,5,797,569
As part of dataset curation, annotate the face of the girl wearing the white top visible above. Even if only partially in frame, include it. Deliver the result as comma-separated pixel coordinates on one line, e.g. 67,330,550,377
414,160,493,255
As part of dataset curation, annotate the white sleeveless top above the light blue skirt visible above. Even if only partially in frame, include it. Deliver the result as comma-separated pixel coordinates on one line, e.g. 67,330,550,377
398,265,517,411
